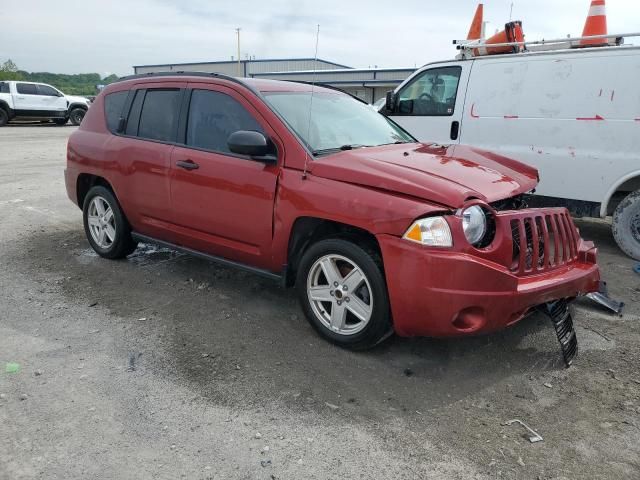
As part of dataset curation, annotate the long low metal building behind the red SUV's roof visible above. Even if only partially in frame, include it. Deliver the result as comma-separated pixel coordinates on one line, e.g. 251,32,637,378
133,58,415,103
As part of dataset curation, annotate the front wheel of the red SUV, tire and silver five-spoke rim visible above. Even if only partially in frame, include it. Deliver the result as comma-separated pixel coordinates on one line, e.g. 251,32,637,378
296,238,393,350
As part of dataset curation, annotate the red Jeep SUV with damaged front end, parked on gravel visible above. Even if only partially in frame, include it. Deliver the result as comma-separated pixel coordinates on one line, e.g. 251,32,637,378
65,73,599,354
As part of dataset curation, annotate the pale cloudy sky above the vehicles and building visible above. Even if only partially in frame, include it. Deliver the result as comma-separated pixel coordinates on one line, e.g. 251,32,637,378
0,0,640,76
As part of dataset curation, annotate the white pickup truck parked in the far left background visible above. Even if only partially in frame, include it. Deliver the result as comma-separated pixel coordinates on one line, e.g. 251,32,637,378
0,81,90,127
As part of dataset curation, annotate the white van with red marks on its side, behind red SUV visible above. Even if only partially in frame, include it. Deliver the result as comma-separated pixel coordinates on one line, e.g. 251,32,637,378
381,39,640,259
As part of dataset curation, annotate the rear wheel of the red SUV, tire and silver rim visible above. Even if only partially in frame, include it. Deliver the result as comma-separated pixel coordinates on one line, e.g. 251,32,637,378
82,186,137,259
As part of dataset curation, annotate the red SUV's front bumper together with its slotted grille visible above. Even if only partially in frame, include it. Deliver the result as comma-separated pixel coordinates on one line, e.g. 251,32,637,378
378,209,600,337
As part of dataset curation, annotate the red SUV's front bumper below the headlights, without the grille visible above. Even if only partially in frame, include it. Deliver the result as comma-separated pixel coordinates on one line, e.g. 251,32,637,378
378,235,600,337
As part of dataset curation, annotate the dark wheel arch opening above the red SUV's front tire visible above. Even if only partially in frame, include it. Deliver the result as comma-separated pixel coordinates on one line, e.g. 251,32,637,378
284,216,382,287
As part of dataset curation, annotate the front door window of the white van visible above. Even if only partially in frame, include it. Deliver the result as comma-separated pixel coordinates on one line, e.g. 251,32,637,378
395,67,462,117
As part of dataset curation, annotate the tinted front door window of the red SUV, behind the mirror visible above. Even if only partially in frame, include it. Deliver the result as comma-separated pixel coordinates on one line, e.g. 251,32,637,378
187,90,264,153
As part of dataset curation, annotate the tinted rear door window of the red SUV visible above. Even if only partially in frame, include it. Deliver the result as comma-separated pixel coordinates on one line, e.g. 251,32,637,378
138,89,182,142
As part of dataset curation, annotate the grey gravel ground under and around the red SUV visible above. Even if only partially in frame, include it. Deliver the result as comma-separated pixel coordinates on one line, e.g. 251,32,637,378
0,126,640,480
